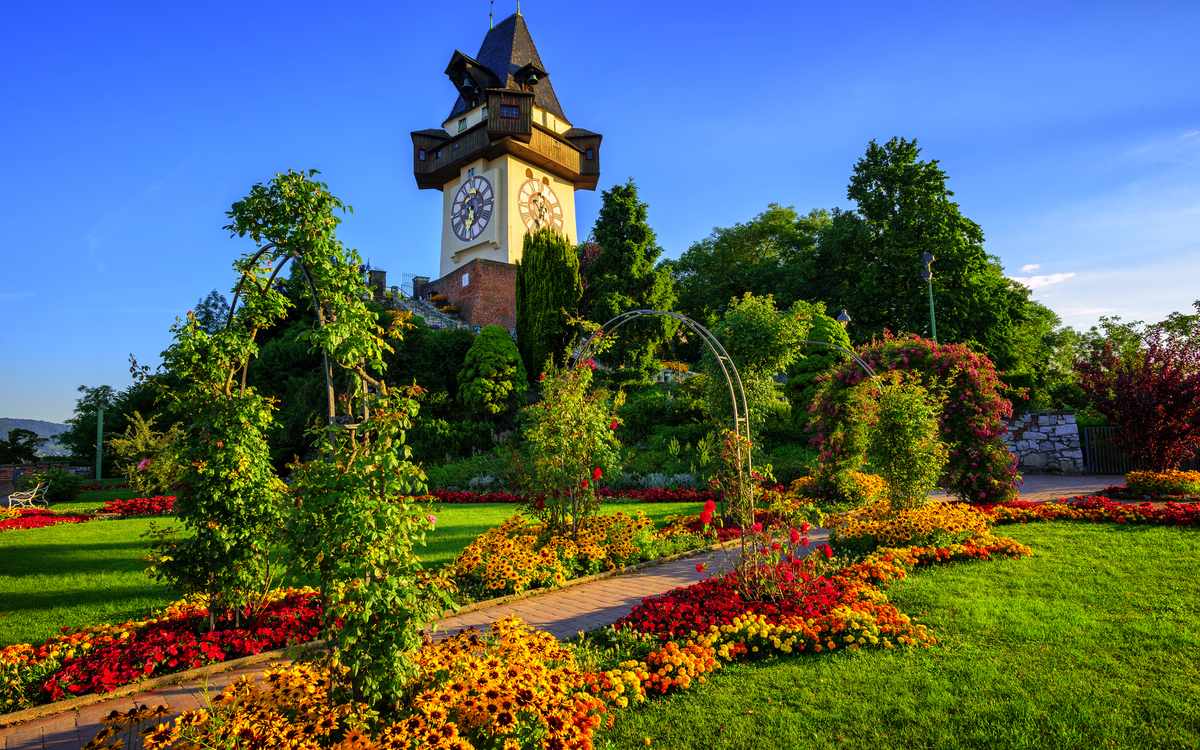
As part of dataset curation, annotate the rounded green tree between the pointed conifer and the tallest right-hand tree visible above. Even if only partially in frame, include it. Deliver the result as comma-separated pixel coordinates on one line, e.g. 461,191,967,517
671,203,832,325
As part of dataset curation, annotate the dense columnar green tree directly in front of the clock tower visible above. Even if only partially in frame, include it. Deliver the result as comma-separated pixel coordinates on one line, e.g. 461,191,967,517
516,228,583,376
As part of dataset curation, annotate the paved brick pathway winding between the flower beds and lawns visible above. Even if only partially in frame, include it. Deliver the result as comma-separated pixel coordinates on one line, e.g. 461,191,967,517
0,475,1123,750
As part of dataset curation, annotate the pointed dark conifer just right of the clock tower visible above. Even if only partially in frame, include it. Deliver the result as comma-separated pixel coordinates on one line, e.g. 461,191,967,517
583,178,676,377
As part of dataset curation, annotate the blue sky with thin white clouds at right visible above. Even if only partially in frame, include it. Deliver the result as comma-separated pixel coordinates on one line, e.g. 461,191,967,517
0,0,1200,421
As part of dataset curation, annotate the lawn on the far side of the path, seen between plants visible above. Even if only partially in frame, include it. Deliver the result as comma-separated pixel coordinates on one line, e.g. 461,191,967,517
0,490,701,648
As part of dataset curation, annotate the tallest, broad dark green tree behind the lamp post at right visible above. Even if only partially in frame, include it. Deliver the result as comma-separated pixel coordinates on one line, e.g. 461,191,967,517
805,138,1027,370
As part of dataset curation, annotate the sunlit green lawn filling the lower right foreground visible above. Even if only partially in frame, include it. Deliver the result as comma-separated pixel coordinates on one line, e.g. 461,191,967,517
598,523,1200,750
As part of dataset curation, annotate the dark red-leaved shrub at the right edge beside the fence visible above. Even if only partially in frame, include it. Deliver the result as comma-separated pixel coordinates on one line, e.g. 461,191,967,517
1075,324,1200,472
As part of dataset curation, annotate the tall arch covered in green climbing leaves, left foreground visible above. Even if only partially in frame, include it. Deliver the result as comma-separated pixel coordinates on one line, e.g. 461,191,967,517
150,170,452,703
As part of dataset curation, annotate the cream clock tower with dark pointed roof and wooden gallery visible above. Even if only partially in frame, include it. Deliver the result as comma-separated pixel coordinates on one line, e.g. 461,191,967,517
412,13,601,328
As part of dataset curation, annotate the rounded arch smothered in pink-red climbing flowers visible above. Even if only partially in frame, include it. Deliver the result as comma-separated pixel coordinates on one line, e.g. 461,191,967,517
808,332,1019,503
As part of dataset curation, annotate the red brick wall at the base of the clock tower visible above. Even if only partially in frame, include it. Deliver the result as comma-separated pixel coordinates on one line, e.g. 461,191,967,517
413,258,517,330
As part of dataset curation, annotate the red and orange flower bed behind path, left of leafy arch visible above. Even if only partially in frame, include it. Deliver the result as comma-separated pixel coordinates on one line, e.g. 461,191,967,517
0,589,320,713
